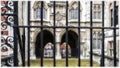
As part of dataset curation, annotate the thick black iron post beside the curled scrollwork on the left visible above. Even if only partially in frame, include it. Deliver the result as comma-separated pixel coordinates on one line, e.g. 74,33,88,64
13,1,18,66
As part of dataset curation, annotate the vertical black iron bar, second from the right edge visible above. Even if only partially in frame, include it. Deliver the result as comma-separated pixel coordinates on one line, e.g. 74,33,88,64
100,1,105,66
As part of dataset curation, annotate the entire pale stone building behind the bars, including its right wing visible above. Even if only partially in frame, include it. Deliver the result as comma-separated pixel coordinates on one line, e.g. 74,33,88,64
0,0,120,66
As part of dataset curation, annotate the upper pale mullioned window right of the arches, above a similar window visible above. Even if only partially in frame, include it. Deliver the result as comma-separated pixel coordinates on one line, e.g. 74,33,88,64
93,4,102,19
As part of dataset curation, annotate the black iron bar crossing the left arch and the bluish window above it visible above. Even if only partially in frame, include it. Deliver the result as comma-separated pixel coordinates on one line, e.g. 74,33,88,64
40,1,43,67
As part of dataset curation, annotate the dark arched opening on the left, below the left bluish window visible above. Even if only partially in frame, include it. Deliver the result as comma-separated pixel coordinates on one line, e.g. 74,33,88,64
35,30,53,58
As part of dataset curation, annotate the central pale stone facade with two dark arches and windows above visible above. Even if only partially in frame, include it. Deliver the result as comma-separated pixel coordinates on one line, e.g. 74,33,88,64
28,1,102,58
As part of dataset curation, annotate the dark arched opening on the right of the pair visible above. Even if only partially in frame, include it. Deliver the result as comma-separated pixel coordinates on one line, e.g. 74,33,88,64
61,30,78,57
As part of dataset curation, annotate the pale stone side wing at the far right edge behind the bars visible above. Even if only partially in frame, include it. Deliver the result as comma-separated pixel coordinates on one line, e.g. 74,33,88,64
105,2,120,57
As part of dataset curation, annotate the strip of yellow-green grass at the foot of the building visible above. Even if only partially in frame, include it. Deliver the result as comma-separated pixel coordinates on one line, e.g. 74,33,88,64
26,58,99,67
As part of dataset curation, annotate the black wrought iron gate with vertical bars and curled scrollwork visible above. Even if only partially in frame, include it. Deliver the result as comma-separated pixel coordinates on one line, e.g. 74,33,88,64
1,1,118,67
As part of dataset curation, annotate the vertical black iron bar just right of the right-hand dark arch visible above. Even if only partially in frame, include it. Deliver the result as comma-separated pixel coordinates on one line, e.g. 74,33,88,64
78,1,81,67
